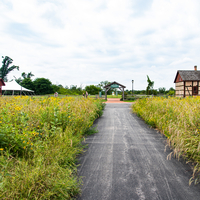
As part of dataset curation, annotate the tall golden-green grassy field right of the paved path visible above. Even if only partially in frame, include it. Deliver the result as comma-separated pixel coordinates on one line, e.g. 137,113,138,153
132,97,200,184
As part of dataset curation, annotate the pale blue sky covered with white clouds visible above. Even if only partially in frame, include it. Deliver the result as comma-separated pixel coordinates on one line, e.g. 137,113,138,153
0,0,200,90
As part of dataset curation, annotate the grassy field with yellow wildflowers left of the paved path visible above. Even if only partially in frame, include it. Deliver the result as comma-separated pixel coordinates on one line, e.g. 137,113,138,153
0,97,104,199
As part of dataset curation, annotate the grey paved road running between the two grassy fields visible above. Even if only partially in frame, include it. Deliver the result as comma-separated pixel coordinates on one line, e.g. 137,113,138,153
78,104,200,200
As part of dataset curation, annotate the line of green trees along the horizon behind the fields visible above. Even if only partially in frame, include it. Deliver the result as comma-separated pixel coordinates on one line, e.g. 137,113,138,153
0,56,175,95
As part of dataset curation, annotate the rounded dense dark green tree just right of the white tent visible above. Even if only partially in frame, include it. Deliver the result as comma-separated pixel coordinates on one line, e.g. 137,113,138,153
33,78,53,95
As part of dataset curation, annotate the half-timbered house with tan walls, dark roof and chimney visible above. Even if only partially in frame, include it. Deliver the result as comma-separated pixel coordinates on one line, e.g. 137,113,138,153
174,66,200,97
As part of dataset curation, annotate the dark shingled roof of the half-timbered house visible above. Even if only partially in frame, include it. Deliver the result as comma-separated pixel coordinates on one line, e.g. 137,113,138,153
174,70,200,83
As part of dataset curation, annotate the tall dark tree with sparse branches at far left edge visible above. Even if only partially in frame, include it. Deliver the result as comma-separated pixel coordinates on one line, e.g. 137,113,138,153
0,56,19,82
